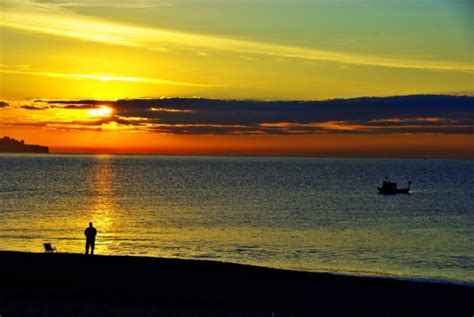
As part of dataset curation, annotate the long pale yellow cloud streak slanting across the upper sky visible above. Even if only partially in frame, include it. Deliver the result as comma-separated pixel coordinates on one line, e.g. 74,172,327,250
0,0,474,72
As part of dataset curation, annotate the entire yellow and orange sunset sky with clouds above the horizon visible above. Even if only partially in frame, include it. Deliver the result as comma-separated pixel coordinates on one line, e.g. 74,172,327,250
0,0,474,157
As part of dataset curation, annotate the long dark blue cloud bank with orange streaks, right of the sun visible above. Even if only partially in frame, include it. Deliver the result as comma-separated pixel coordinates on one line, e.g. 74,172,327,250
12,95,474,134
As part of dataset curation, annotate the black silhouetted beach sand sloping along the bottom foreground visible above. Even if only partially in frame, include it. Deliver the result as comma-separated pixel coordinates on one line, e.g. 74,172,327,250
0,252,474,317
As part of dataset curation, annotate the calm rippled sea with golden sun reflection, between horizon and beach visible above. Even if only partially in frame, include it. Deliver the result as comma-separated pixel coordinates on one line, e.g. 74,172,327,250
0,154,474,283
